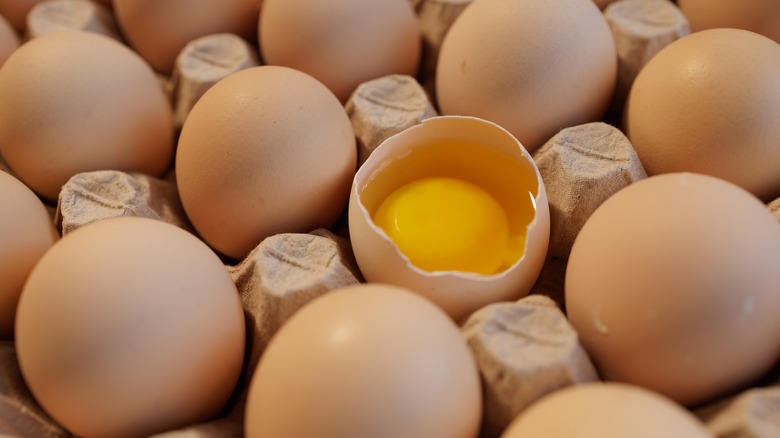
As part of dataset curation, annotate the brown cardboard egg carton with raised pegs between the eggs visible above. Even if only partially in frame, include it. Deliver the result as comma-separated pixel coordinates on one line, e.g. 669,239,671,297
0,0,780,438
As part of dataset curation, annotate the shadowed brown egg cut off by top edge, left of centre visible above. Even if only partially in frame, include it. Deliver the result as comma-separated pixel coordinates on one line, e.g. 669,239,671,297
114,0,262,74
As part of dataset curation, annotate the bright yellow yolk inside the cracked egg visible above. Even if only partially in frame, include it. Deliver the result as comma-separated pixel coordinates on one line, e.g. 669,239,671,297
374,177,509,274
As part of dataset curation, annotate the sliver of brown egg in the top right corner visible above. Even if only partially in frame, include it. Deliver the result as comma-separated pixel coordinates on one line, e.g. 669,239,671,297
677,0,780,43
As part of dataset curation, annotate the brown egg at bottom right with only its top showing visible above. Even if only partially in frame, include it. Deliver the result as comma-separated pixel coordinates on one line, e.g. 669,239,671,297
501,382,714,438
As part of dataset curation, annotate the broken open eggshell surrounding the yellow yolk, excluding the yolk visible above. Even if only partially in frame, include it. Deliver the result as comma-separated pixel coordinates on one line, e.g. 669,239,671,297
349,116,550,321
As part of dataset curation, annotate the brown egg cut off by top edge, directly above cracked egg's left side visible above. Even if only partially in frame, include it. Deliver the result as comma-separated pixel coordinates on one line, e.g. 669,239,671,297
258,0,422,102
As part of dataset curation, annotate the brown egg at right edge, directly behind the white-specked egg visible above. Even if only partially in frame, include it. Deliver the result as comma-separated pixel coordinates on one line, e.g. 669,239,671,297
625,29,780,201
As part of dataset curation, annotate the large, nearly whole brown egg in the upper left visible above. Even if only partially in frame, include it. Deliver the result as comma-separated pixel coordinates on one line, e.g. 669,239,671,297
0,31,174,200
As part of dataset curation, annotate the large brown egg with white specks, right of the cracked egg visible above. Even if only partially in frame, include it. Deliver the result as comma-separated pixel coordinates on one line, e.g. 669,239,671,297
565,173,780,406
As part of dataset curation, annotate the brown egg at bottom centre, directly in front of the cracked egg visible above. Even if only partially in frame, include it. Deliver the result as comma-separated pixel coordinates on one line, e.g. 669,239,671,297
244,284,482,438
